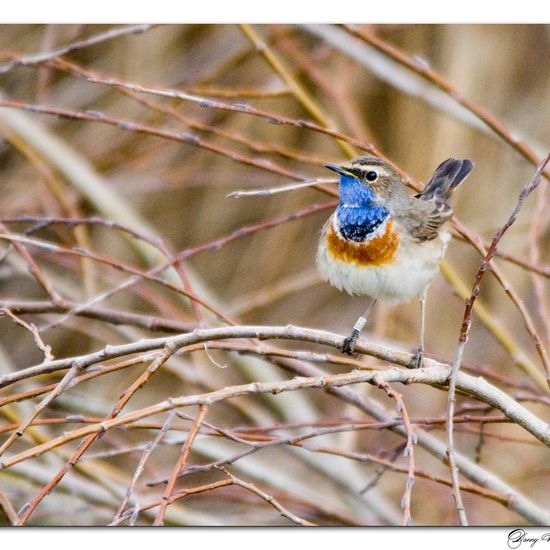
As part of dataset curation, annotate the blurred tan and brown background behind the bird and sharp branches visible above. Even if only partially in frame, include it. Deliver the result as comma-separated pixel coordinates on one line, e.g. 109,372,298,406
0,25,550,525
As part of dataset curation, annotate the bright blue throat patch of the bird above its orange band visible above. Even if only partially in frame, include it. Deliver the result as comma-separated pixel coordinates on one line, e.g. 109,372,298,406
336,175,390,242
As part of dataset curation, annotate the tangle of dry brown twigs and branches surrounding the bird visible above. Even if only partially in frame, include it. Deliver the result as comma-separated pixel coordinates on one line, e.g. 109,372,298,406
0,25,550,525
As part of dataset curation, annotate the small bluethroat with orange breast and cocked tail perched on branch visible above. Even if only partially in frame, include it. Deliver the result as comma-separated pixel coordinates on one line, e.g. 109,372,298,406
317,157,474,368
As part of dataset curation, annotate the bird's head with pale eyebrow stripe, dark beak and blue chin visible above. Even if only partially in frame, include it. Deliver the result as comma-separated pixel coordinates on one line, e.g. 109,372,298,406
325,157,402,206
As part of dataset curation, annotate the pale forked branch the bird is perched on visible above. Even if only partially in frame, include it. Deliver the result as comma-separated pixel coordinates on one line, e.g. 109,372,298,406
0,325,550,450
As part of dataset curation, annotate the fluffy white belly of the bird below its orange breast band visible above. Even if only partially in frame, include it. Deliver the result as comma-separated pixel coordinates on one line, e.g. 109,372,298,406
317,232,451,304
